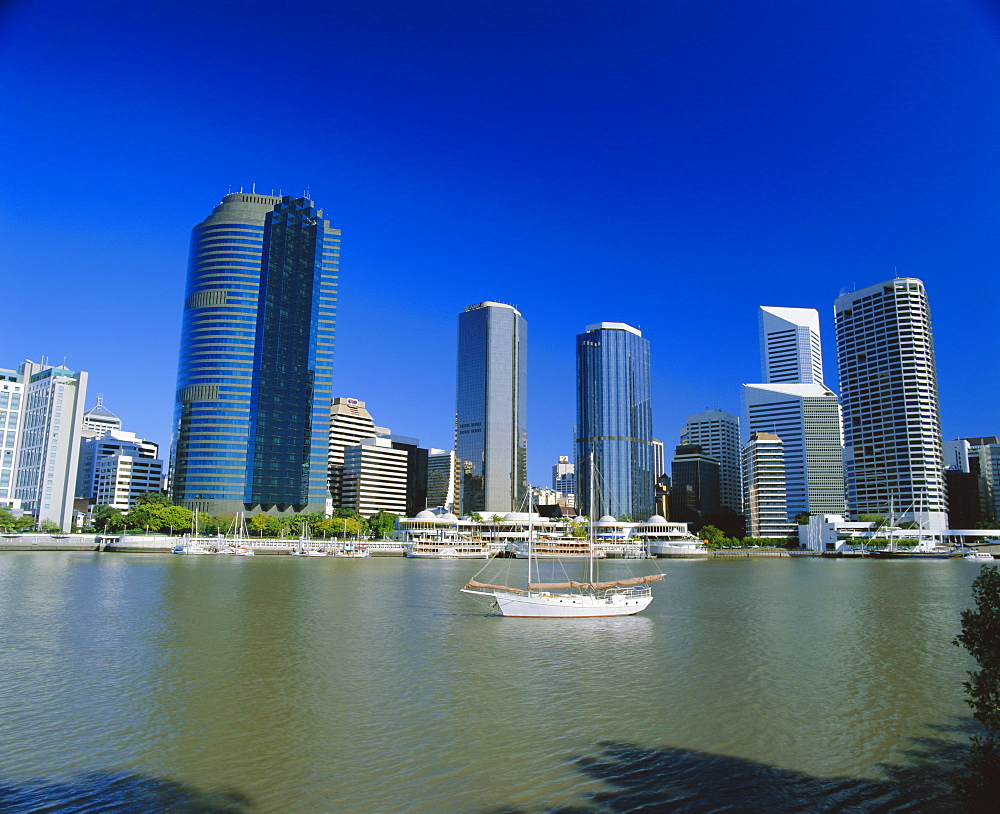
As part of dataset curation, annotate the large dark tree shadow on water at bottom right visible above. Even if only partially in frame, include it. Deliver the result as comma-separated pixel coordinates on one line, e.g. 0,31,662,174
488,721,971,814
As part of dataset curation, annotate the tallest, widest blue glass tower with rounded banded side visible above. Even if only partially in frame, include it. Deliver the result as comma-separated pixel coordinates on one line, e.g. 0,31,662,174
170,192,340,514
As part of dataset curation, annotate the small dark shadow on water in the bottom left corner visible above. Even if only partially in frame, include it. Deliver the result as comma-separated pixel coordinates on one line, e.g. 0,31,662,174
0,772,254,814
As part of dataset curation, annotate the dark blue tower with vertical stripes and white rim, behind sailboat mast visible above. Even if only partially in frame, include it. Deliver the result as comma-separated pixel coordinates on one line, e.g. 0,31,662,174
576,322,655,520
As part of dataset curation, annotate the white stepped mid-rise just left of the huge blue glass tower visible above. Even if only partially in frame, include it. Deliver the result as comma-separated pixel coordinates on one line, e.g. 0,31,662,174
76,430,163,511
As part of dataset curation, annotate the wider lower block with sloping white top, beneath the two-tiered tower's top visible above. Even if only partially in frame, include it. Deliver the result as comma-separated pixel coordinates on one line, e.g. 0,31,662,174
743,383,844,520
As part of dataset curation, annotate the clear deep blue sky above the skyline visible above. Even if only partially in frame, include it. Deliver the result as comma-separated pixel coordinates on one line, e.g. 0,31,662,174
0,0,1000,484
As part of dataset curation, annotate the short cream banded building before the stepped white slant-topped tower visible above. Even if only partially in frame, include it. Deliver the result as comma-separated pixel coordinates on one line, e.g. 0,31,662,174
743,432,797,538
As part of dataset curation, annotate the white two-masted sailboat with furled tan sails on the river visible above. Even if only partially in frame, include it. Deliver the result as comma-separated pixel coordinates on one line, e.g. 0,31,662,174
461,464,663,619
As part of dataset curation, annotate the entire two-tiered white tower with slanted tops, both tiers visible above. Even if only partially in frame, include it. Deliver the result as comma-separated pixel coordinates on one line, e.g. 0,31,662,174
742,307,845,520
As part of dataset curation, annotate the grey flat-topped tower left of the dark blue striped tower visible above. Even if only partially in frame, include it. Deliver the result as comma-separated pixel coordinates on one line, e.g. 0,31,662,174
455,302,528,515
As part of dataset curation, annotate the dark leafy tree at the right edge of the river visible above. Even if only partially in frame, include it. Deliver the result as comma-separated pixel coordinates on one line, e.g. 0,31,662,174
953,567,1000,812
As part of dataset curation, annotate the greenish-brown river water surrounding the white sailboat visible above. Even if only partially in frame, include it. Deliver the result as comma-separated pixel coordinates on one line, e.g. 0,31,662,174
0,552,979,812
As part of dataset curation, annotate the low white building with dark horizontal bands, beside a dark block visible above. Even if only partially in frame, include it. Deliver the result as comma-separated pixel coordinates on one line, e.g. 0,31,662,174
341,438,409,517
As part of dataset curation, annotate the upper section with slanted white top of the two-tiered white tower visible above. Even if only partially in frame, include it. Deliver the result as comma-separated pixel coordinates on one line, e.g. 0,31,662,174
758,305,823,384
